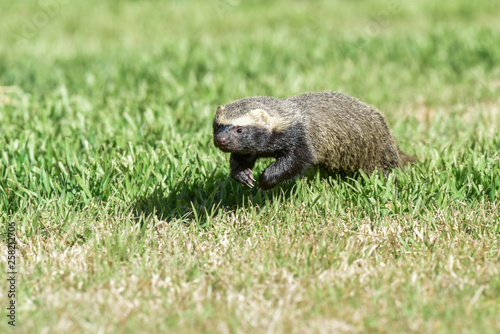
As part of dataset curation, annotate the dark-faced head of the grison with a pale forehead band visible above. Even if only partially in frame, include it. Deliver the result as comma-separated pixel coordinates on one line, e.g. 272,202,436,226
213,98,283,154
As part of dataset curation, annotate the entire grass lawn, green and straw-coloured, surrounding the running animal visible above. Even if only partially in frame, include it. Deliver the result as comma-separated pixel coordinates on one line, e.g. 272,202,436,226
0,0,500,333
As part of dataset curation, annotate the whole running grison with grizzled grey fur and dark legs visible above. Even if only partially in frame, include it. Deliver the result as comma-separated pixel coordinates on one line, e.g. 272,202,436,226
213,93,416,190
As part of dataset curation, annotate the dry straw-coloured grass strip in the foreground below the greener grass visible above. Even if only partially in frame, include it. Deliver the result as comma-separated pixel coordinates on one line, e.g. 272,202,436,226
0,203,500,333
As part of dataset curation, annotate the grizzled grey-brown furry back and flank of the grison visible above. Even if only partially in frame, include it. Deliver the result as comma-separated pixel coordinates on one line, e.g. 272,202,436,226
281,93,400,174
